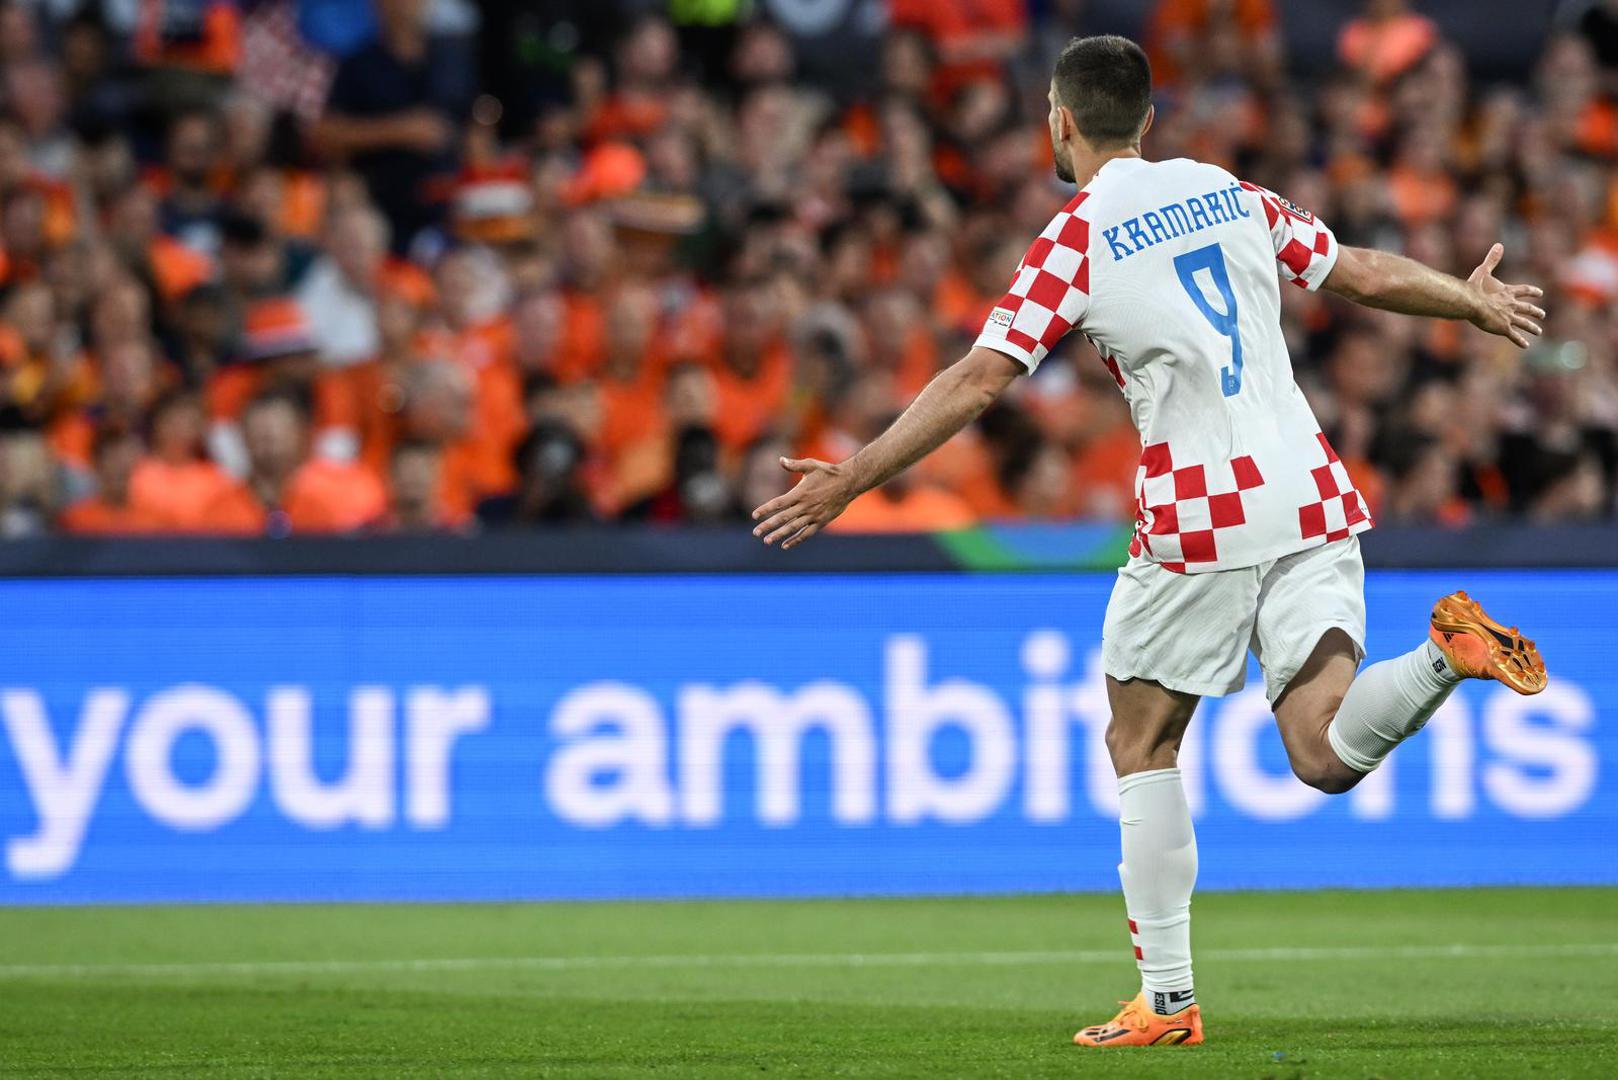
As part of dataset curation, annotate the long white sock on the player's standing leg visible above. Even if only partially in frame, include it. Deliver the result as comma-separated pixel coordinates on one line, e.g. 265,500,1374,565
1118,769,1197,1015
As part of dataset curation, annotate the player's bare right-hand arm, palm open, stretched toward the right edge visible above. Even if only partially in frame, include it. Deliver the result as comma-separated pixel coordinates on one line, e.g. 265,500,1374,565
1320,244,1545,348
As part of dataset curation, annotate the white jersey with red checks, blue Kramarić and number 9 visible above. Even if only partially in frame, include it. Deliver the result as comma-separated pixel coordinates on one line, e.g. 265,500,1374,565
977,157,1370,573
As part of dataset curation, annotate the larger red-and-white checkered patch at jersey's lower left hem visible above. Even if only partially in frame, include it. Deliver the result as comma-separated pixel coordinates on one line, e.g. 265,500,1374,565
1129,442,1264,573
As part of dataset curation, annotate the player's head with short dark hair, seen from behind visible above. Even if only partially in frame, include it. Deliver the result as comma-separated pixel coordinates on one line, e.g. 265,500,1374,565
1052,34,1152,147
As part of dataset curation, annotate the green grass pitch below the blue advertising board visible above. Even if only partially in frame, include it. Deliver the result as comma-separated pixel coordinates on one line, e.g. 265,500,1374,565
0,889,1618,1080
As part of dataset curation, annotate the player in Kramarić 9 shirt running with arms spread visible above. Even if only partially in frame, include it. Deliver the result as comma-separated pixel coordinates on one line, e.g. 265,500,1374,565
752,36,1545,1046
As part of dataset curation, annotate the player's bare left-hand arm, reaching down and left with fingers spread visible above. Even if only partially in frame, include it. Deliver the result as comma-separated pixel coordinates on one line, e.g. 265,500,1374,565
752,347,1023,549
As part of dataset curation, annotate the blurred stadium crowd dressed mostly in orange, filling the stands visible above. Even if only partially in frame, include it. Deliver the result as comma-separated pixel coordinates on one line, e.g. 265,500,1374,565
0,0,1618,536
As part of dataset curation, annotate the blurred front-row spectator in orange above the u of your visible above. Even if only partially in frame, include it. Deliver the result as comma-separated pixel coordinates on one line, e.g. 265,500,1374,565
204,390,387,536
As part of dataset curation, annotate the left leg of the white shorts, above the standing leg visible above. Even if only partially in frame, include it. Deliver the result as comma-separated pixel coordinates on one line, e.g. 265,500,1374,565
1102,559,1262,696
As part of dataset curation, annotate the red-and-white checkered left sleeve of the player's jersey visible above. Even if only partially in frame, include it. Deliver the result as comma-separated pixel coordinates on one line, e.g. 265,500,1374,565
976,191,1091,374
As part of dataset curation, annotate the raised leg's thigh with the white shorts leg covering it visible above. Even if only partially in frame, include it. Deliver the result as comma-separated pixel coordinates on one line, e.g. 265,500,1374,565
1252,538,1366,718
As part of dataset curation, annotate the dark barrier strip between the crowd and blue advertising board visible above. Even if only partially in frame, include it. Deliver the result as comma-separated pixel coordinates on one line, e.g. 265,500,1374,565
0,525,1618,578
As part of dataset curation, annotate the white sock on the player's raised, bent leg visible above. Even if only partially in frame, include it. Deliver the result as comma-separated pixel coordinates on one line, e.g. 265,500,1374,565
1325,641,1461,772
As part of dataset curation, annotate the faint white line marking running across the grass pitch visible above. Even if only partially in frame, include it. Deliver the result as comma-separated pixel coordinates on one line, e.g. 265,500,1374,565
0,942,1618,980
